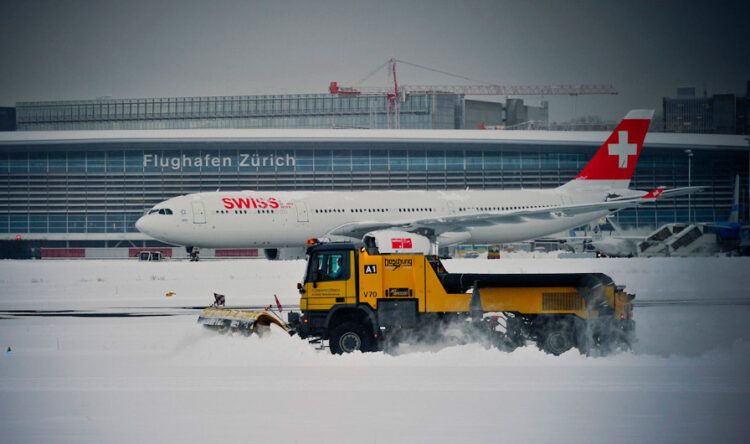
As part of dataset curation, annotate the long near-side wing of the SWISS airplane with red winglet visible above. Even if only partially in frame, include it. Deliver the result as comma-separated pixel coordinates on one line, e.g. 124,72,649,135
326,187,704,239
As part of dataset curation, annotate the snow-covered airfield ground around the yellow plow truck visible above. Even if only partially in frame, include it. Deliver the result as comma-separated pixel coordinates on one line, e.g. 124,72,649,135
0,258,750,443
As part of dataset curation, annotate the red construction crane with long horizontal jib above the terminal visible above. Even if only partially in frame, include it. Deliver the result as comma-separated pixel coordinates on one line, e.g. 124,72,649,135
328,57,617,128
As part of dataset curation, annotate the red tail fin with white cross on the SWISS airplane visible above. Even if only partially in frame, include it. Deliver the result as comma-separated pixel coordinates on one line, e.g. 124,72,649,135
563,110,654,189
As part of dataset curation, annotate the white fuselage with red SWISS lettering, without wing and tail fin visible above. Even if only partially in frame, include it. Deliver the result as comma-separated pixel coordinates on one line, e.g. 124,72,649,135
136,188,608,248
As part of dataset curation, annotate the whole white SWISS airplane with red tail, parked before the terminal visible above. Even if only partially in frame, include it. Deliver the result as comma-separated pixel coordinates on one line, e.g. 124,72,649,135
136,110,701,259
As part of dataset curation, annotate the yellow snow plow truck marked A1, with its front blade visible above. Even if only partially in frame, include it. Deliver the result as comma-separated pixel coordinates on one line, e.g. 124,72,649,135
199,242,635,355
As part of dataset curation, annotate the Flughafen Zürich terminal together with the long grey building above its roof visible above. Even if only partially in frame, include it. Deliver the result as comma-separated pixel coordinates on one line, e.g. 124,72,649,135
0,94,750,258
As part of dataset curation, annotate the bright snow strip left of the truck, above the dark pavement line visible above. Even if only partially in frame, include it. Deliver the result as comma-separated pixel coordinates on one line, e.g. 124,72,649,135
0,260,305,310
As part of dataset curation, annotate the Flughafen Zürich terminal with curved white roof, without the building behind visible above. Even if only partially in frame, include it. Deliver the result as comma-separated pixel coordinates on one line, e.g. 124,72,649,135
0,129,750,255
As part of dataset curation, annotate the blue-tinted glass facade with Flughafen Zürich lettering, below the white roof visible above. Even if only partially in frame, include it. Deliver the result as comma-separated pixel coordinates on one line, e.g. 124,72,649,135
0,137,748,237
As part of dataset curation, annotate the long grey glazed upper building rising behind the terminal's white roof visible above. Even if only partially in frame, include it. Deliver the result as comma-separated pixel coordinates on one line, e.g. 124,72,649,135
16,94,463,131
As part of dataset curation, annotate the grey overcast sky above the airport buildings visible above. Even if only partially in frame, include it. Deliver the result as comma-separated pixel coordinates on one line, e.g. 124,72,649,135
0,0,750,120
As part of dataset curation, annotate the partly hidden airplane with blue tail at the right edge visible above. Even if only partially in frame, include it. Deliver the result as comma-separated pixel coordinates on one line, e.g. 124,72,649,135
590,174,748,257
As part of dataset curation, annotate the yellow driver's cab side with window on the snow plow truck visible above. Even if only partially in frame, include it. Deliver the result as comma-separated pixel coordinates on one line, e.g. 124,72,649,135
300,250,356,310
